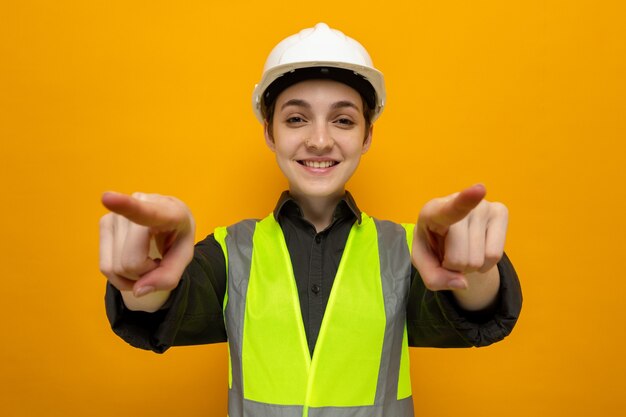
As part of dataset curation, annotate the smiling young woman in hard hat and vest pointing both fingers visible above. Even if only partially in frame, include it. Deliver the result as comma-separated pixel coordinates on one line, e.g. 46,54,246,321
100,23,521,417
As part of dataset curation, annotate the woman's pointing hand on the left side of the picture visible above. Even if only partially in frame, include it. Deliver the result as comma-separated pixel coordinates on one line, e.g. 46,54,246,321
100,192,195,311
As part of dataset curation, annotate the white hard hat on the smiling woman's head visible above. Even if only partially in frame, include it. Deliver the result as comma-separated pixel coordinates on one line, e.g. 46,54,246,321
252,23,385,123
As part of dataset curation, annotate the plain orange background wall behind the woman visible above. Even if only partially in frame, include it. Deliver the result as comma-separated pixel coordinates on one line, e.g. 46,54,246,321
0,0,626,417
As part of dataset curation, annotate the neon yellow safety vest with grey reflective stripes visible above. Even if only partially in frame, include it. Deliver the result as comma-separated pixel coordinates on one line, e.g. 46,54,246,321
215,213,413,417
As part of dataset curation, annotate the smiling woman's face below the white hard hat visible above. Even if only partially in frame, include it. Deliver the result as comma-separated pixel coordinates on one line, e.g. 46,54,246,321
265,80,372,202
